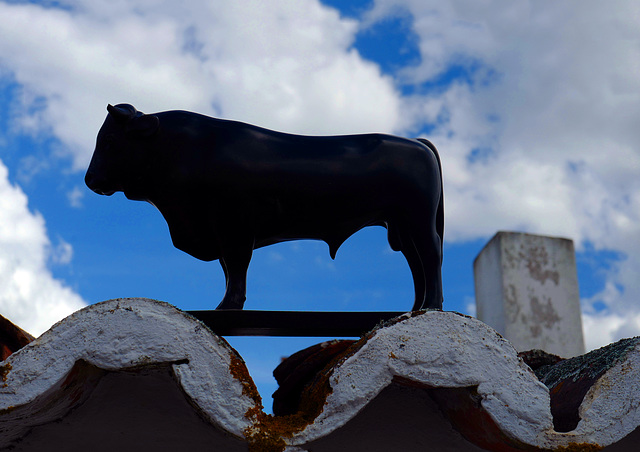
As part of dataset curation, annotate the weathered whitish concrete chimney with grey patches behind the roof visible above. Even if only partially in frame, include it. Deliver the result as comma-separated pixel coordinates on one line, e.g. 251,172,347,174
473,231,585,358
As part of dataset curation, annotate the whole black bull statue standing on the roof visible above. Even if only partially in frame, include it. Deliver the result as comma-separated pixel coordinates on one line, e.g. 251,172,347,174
85,104,444,310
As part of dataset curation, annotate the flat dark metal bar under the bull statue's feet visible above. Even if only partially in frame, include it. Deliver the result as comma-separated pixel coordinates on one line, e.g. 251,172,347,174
187,309,404,337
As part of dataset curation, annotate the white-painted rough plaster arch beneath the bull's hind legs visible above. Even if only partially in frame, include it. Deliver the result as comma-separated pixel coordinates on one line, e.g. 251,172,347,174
290,311,553,445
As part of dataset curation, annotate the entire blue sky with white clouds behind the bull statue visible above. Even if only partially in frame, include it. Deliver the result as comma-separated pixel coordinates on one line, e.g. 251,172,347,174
0,0,640,405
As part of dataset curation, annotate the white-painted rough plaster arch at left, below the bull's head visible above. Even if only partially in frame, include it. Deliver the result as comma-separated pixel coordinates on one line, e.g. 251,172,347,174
0,299,254,448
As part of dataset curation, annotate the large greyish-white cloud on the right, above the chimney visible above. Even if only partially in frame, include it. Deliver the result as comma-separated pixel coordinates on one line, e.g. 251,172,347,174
367,0,640,346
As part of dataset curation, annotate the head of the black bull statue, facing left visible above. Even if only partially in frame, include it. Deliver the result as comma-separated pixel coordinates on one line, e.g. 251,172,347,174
85,104,160,199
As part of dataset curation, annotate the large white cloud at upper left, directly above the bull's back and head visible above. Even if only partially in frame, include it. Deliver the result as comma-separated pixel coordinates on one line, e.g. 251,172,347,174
0,0,400,168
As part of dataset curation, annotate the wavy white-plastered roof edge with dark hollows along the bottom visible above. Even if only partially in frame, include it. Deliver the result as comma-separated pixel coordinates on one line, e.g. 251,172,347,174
0,299,640,452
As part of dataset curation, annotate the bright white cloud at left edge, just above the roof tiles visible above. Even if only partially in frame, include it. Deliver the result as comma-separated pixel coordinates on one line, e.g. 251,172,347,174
0,162,85,336
